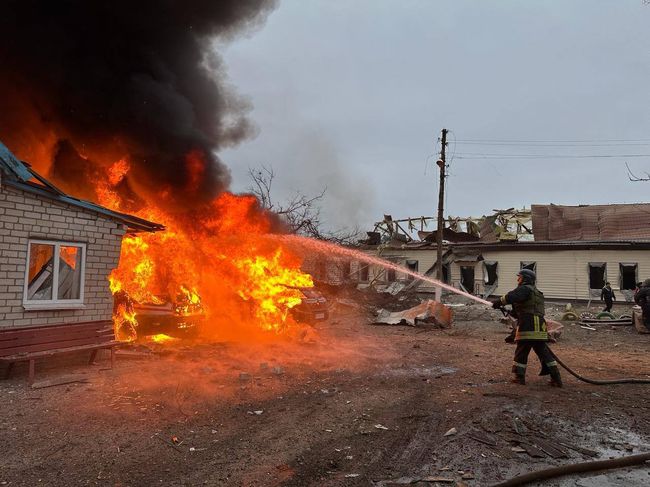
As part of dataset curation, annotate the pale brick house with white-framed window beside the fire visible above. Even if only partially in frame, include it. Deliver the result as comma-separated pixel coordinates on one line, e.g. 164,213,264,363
0,143,164,329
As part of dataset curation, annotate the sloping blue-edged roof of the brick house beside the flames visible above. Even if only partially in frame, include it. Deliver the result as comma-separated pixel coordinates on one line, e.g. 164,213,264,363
0,142,165,232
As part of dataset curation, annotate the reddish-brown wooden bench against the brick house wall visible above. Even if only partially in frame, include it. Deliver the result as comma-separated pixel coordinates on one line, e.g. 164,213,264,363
0,321,120,385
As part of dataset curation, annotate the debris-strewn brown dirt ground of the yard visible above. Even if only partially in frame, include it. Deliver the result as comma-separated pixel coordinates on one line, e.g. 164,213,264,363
0,300,650,487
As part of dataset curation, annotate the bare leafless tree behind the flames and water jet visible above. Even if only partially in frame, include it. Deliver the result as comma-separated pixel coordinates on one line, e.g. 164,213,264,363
248,165,360,245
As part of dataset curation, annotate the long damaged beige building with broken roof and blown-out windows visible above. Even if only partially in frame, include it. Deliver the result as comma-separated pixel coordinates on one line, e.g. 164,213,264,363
312,203,650,301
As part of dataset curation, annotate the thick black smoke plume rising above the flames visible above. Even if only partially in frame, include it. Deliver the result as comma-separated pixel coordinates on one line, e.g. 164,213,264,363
0,0,275,209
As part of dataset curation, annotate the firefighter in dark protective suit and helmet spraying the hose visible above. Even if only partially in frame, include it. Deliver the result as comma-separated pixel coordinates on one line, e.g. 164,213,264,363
492,269,562,387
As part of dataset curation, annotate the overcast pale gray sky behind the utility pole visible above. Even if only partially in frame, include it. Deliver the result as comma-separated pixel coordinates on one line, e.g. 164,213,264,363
220,0,650,234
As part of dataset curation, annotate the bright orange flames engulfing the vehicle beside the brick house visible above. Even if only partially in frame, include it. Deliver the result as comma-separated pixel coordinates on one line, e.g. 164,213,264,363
97,153,313,343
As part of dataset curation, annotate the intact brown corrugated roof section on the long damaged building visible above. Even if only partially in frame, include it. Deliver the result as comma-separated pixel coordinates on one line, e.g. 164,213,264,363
531,203,650,242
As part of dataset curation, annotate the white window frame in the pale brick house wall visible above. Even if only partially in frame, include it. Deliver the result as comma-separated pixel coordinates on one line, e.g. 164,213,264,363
23,239,86,310
